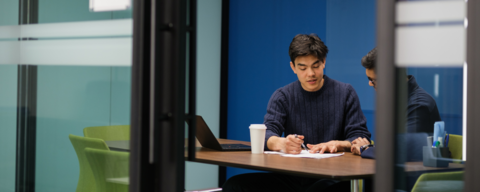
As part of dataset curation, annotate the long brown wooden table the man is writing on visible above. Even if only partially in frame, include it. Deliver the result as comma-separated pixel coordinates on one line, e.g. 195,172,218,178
106,139,464,191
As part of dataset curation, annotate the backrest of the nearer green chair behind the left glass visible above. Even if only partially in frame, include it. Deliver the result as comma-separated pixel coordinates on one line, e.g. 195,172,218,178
68,134,109,192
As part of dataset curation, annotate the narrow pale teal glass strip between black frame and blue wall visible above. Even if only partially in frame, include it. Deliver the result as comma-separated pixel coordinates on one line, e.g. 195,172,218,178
185,0,223,190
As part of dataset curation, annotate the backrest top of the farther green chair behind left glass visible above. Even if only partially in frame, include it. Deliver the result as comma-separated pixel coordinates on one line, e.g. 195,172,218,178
83,125,130,141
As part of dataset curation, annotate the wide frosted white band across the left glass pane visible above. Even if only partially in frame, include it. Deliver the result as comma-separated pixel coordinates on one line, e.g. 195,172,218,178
0,19,133,66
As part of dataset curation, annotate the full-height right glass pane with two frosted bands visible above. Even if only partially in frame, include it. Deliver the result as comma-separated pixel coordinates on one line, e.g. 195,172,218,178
392,1,467,191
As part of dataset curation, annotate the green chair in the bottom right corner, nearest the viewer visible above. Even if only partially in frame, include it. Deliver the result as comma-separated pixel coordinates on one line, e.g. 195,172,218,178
412,171,463,192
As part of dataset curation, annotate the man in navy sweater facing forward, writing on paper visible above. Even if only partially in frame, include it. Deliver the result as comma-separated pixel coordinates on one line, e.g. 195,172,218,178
223,34,370,191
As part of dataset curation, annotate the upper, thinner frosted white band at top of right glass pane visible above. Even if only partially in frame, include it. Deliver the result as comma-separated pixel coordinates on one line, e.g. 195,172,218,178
396,0,466,24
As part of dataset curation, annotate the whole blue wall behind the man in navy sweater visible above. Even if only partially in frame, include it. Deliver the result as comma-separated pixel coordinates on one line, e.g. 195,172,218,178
227,0,375,178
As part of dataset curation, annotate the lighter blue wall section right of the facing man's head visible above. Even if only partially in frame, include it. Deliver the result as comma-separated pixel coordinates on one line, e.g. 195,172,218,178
325,0,376,140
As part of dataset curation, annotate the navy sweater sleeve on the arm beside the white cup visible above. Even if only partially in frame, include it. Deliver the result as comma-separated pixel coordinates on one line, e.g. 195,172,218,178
264,90,287,150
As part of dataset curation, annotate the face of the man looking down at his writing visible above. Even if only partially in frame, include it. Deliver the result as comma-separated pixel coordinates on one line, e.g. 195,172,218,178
290,55,325,92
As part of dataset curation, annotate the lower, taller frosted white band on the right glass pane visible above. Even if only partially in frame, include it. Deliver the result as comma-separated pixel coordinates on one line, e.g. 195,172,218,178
395,25,466,67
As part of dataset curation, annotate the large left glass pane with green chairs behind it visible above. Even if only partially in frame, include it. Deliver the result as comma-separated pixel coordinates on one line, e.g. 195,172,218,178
0,0,133,192
